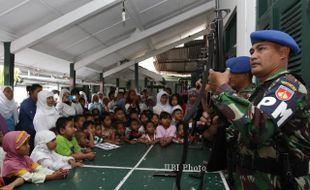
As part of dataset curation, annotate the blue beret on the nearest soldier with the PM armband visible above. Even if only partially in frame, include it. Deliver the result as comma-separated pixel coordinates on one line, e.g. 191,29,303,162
250,30,300,54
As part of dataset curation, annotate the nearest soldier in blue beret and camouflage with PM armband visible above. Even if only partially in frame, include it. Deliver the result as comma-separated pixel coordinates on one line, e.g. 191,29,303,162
203,30,310,190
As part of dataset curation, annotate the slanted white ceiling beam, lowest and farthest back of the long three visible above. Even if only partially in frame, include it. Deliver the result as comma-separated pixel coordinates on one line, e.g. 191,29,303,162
103,29,209,78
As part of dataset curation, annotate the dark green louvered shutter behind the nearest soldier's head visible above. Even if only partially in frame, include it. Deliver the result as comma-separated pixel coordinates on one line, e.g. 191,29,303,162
257,0,310,89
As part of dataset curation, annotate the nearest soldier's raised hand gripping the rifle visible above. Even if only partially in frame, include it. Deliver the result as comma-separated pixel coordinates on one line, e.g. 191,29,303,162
205,69,230,92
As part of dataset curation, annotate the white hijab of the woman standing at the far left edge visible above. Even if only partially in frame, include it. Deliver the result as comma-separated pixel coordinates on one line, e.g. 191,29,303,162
0,86,18,124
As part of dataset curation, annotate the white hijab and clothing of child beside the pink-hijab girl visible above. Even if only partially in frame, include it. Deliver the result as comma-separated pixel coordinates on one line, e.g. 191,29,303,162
30,130,73,170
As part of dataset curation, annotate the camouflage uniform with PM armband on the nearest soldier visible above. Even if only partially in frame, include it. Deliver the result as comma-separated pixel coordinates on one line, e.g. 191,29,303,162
213,71,310,190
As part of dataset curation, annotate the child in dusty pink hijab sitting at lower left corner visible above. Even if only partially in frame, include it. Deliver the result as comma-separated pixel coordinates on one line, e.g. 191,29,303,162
3,131,69,183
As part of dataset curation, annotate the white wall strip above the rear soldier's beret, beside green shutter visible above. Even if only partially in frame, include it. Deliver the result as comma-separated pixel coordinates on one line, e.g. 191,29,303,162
219,0,256,56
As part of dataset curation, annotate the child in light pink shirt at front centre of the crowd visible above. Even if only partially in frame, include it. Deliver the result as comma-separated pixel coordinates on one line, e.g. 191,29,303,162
156,112,176,147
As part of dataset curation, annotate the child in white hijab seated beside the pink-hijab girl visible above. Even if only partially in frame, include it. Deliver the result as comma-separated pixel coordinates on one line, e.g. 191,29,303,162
30,130,82,170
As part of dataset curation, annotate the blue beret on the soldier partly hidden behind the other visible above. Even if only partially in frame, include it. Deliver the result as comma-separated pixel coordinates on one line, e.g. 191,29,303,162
225,56,251,74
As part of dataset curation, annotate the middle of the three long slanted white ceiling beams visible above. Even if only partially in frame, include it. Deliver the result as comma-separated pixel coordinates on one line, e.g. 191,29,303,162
75,1,215,70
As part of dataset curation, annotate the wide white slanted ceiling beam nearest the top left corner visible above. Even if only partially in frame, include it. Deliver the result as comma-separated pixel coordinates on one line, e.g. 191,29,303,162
11,0,121,53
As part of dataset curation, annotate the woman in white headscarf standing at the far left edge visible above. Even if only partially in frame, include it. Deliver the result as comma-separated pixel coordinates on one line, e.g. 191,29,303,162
0,86,18,131
